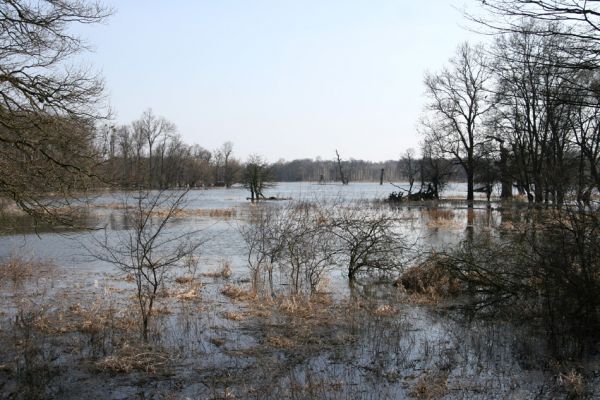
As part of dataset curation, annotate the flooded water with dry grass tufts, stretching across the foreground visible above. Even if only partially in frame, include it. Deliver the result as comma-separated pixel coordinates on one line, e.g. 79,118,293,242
0,183,598,399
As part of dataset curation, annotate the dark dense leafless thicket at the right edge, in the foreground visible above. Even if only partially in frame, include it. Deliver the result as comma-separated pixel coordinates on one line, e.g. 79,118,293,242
438,209,600,357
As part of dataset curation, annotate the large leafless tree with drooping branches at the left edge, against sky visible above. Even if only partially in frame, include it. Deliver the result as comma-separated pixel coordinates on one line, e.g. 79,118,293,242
0,0,110,219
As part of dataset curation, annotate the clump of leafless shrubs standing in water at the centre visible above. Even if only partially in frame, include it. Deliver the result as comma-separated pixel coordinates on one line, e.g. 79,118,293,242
240,201,408,295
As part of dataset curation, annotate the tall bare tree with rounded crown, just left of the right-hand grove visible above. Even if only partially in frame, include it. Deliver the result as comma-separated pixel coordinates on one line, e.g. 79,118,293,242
424,43,491,202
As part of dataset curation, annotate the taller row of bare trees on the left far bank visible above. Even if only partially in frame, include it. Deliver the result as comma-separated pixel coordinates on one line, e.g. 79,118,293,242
97,109,242,189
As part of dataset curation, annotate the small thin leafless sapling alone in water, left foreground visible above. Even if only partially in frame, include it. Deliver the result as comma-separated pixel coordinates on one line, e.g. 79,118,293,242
89,191,203,341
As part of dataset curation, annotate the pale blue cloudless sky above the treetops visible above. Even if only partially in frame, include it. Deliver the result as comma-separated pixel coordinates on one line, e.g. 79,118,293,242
82,0,479,161
